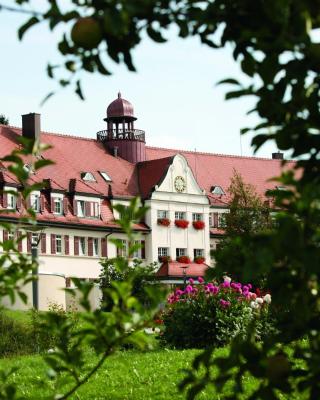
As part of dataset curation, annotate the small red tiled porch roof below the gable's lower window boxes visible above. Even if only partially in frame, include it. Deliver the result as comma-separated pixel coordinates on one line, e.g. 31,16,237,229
156,261,209,278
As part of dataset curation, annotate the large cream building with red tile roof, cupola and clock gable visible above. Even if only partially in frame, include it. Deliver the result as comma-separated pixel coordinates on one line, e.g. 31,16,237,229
0,93,292,288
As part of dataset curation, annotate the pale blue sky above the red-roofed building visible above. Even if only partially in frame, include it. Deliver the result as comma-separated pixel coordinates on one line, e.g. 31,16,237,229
0,0,276,158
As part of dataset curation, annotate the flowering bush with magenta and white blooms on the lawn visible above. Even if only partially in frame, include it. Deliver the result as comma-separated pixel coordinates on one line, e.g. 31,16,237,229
161,277,271,348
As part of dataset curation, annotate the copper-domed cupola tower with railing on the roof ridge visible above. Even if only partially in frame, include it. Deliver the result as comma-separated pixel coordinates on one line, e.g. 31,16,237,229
97,92,146,164
